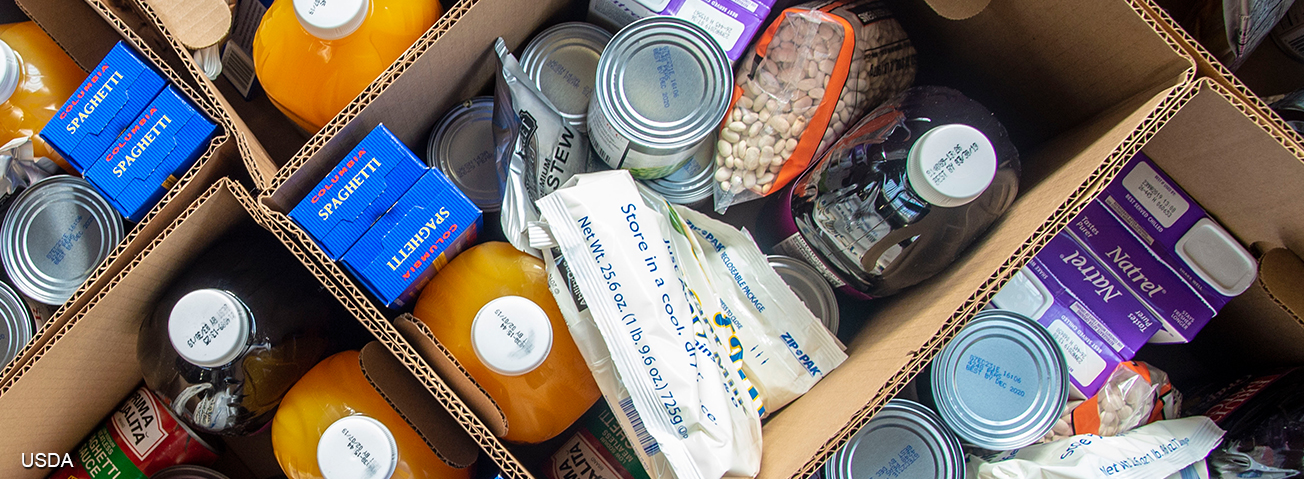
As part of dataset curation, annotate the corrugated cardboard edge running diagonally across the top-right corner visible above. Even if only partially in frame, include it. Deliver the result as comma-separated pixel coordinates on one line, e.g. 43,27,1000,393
1146,0,1304,159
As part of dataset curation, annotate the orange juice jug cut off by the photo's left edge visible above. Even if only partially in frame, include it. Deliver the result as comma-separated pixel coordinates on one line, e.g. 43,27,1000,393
0,22,86,172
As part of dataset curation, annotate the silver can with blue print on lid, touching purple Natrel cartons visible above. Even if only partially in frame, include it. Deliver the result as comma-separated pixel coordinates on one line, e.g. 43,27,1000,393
919,309,1069,450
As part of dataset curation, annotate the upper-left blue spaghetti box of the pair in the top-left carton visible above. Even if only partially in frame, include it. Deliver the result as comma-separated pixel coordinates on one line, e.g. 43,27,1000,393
40,42,167,174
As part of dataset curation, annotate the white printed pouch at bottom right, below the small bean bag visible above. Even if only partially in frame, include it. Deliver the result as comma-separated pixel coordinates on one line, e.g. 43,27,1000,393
965,416,1223,479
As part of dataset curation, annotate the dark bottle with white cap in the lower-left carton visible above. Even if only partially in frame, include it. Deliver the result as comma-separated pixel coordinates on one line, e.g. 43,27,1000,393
136,227,344,436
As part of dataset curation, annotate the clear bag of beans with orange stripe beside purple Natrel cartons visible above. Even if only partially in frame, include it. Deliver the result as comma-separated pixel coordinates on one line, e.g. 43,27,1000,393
1043,362,1181,442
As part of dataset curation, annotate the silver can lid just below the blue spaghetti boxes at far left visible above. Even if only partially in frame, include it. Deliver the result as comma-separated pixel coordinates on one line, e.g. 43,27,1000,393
0,175,124,305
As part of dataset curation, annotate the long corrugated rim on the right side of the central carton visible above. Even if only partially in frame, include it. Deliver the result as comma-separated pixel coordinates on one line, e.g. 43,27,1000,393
762,0,1198,479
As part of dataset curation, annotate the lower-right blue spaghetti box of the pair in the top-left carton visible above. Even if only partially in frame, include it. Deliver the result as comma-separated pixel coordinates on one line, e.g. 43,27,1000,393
85,86,216,222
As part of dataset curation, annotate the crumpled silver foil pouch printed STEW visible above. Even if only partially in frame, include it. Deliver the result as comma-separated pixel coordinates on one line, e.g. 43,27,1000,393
493,38,589,256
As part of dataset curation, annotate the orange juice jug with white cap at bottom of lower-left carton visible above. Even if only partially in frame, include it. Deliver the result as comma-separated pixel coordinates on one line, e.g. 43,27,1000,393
271,351,471,479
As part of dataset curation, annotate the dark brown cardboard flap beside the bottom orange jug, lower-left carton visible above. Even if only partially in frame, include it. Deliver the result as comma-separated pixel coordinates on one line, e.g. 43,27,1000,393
360,341,480,469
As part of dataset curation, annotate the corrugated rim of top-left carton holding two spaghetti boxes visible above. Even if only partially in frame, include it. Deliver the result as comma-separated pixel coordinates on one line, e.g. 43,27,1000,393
0,3,230,380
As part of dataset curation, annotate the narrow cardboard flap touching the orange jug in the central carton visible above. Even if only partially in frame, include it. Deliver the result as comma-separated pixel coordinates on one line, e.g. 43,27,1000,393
394,315,509,436
